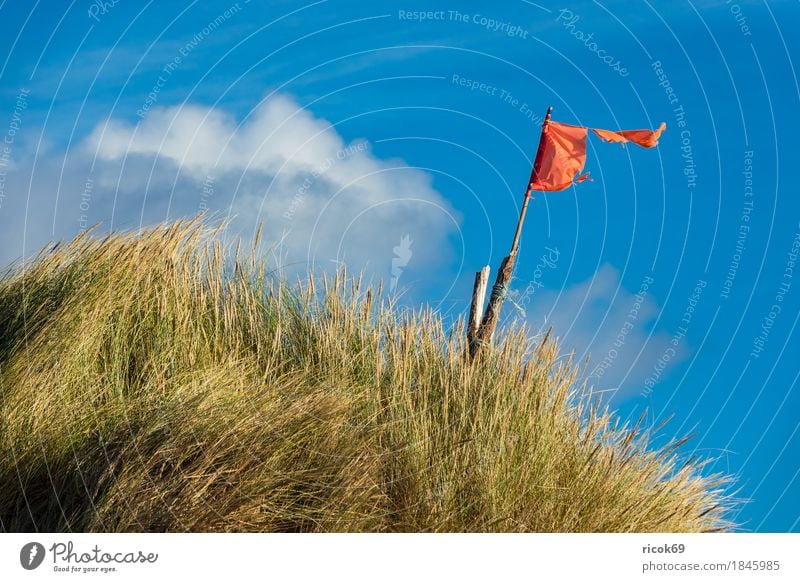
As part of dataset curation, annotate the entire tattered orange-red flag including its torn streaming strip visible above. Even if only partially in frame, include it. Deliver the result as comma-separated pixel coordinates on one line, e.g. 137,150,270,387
530,121,667,192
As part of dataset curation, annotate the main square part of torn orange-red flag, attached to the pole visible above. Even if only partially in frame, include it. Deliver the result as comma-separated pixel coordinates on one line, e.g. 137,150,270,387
530,121,589,192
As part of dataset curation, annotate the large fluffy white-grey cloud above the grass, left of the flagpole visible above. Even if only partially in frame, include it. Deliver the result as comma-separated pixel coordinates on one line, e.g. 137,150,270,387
0,95,459,286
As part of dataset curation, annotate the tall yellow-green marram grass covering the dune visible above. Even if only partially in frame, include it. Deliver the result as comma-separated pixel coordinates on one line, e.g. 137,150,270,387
0,222,729,532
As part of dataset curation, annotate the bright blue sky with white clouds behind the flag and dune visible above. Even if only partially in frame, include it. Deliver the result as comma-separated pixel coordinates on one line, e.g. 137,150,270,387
0,0,800,531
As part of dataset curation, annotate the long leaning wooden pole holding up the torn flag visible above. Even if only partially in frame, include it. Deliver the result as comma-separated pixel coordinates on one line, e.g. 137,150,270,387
470,107,553,356
